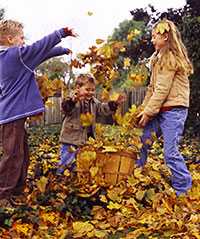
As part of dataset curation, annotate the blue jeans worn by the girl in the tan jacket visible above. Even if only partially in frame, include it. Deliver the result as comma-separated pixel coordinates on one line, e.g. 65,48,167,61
137,108,192,195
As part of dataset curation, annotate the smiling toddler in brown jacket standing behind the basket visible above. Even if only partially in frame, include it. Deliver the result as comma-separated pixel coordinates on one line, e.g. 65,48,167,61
57,74,124,173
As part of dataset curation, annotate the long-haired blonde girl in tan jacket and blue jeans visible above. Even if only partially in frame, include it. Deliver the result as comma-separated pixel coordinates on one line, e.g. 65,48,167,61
137,20,193,195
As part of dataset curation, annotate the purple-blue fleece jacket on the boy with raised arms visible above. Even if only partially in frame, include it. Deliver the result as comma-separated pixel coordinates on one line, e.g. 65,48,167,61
0,29,68,124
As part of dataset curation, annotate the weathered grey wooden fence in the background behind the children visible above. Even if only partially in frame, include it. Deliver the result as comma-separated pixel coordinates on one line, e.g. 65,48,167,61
30,87,146,126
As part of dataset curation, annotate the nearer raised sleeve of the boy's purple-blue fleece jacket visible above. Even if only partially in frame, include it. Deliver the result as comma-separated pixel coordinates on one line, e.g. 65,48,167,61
19,29,66,70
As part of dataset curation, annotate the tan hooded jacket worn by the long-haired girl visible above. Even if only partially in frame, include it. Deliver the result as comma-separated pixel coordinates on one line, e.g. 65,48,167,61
142,52,190,117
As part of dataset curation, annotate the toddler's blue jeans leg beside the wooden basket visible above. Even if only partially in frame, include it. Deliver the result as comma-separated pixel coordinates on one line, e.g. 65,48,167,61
57,144,78,174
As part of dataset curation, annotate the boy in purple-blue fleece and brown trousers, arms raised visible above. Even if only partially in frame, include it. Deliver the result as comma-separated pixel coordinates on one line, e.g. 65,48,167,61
0,20,76,207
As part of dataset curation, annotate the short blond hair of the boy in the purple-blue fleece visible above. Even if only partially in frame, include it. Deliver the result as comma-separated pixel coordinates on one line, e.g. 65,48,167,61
0,20,23,44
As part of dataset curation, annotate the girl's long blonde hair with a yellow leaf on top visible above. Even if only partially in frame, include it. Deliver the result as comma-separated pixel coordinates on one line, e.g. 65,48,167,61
153,19,193,75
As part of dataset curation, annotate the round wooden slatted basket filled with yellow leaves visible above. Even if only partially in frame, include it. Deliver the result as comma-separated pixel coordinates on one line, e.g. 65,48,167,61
77,151,137,186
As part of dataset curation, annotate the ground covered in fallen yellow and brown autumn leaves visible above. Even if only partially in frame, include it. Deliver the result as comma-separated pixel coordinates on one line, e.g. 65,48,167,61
0,126,200,239
